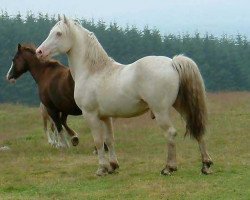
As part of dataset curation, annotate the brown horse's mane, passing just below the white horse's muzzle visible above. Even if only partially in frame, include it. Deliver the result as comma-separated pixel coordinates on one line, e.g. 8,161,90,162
21,44,65,67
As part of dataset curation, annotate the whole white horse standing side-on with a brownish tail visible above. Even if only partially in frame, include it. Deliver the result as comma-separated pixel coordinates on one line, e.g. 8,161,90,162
36,16,212,176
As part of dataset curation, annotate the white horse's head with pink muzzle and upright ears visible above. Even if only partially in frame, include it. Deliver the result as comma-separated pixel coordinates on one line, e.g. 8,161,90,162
36,15,73,59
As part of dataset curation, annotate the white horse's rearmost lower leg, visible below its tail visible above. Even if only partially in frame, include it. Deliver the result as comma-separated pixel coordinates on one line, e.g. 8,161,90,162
198,137,213,174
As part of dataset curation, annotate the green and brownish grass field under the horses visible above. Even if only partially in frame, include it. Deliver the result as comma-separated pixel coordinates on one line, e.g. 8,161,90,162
0,92,250,200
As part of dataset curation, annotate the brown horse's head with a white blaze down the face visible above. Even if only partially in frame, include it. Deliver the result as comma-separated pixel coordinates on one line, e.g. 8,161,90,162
6,44,28,83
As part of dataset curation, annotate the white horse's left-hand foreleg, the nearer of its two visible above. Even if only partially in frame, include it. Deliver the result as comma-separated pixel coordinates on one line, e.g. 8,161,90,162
84,113,113,176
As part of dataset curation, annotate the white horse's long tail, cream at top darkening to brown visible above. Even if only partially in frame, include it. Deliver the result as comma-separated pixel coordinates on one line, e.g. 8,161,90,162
173,55,207,140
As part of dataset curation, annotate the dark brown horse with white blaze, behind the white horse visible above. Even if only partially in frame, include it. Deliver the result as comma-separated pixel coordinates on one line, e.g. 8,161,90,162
6,44,82,147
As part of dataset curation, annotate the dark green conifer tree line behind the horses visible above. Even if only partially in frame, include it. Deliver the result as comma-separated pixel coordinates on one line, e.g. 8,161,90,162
0,12,250,104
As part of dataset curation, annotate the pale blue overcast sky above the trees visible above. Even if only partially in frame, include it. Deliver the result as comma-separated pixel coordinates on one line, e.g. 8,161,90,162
0,0,250,38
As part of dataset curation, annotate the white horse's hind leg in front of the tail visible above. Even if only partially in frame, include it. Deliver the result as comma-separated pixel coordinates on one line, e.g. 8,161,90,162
155,111,177,175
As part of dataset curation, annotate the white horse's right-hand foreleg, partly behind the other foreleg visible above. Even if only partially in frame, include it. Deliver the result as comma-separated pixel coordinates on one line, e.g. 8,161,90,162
103,117,119,171
